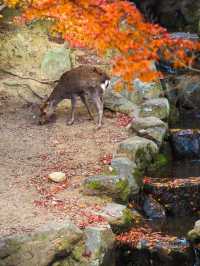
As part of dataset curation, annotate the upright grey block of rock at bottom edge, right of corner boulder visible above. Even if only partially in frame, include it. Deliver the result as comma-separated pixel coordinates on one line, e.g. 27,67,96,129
85,225,115,266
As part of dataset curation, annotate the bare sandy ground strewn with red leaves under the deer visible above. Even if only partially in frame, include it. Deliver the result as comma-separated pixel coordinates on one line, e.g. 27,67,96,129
0,93,127,236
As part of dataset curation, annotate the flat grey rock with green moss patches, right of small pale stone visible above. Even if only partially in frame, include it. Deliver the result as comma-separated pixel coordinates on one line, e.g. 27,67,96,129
84,175,138,202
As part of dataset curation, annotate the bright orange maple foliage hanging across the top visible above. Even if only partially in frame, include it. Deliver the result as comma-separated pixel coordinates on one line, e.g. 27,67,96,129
1,0,200,90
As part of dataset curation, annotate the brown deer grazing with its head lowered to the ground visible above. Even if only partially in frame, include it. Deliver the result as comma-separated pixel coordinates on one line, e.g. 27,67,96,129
36,66,110,129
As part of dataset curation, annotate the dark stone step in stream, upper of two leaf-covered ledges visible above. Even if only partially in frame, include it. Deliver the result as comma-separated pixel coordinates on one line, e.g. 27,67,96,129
144,177,200,216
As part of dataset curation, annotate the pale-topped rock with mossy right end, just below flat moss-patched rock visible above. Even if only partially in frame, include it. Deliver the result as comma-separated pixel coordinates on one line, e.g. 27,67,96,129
93,202,141,233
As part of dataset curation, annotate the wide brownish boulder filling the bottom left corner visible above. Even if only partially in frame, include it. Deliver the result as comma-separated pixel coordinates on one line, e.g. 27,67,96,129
0,221,84,266
